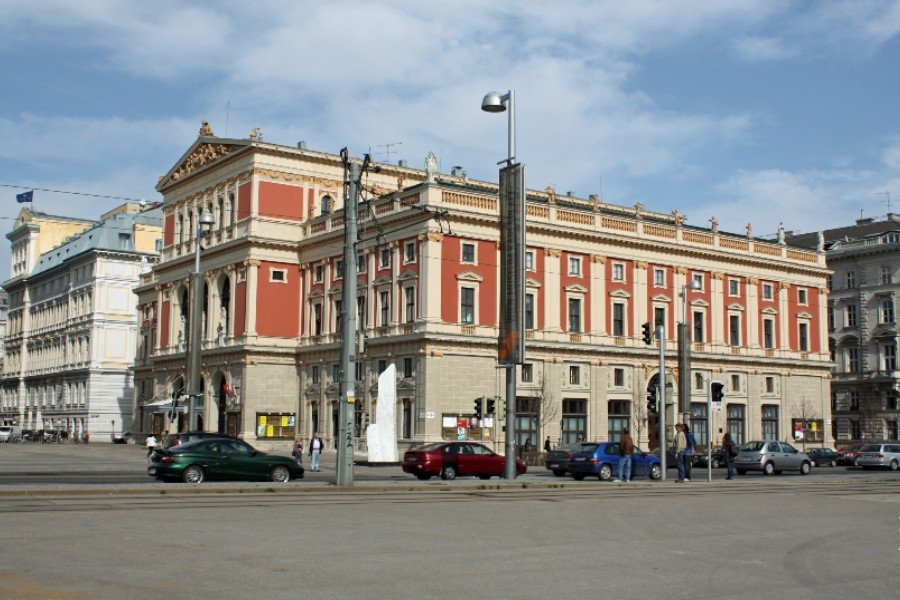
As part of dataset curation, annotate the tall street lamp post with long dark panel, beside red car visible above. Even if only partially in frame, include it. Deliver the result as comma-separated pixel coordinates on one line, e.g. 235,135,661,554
481,90,525,480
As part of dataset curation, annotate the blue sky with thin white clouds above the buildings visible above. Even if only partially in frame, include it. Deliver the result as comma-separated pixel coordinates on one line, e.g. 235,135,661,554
0,0,900,281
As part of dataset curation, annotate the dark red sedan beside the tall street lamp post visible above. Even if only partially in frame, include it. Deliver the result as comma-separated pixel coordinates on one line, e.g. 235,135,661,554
403,442,527,480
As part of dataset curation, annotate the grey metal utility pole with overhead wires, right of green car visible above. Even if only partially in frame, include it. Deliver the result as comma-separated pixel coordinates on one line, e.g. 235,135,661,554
335,158,360,486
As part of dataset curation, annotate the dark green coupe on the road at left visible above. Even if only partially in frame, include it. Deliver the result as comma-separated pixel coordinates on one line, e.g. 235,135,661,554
147,439,303,483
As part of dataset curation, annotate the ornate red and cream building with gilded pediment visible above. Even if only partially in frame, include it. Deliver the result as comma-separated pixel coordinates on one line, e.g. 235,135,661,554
135,131,831,451
